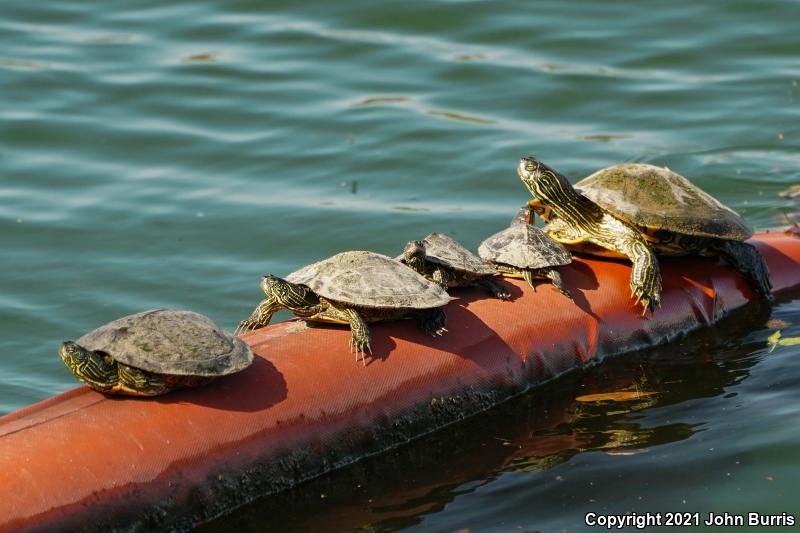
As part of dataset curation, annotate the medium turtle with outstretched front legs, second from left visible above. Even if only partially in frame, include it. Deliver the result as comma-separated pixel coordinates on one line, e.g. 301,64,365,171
236,251,450,364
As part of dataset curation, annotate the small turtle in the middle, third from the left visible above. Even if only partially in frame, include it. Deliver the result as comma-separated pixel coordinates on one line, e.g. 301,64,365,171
396,233,511,300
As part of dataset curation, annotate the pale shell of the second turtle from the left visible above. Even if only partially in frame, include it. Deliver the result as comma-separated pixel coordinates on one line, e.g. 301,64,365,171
286,251,450,309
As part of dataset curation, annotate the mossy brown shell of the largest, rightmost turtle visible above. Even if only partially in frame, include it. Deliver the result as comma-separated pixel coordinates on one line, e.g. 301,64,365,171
575,163,753,241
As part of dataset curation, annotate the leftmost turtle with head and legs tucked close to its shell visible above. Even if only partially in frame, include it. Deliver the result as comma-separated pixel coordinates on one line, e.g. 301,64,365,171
58,309,253,396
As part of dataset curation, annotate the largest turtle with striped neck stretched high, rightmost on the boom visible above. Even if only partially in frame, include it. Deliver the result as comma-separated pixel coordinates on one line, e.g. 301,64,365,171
517,157,772,315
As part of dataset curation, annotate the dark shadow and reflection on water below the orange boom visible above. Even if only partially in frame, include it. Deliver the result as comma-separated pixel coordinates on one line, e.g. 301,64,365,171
201,294,784,532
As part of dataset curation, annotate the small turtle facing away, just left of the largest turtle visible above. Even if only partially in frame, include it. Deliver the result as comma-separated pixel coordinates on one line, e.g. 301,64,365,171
478,205,572,299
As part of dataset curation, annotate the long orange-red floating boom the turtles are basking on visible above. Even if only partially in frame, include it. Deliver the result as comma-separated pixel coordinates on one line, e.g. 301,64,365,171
0,233,800,531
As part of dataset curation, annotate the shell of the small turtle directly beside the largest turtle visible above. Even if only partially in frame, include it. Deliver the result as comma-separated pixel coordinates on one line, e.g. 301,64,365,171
478,224,572,268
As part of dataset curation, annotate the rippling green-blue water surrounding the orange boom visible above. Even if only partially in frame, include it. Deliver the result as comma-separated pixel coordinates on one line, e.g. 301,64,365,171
0,0,800,530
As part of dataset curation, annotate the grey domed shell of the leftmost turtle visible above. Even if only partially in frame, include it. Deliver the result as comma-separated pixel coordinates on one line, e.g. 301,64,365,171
76,309,253,376
